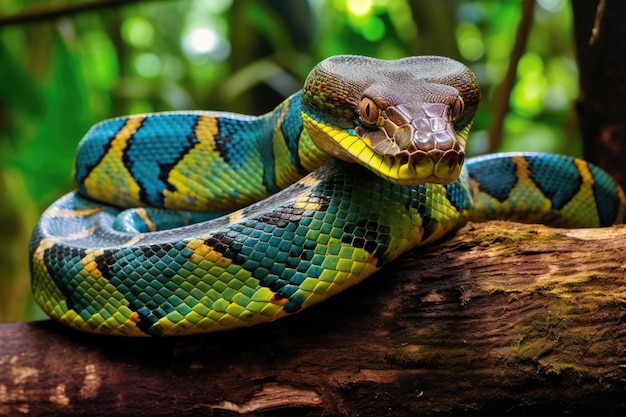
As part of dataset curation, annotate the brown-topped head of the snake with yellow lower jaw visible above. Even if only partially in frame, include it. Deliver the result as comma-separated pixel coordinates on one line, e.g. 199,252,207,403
302,55,480,185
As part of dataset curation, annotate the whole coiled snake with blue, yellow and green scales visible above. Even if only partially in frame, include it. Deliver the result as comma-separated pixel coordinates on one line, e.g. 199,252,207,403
29,55,626,336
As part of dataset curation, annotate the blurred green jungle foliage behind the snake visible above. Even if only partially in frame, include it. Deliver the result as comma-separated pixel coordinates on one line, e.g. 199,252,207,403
0,0,582,322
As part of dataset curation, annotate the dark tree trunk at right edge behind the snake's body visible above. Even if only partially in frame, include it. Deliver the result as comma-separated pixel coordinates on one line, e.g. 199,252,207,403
572,0,626,188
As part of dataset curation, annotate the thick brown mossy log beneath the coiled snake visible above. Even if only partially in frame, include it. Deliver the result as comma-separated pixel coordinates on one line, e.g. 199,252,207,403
0,222,626,416
